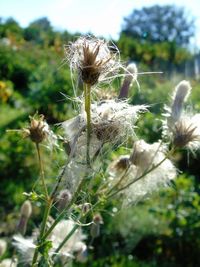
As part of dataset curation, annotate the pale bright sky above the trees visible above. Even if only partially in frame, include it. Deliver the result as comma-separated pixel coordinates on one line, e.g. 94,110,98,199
0,0,200,44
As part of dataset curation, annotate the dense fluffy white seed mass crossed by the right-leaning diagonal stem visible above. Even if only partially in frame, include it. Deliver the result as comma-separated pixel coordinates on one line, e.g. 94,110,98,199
111,140,176,205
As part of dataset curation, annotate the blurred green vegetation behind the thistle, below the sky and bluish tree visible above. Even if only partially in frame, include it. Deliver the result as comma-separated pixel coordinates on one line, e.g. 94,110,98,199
0,5,200,267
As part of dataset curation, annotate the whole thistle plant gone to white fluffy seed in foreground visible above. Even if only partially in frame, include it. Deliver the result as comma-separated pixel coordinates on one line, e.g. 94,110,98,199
1,37,200,267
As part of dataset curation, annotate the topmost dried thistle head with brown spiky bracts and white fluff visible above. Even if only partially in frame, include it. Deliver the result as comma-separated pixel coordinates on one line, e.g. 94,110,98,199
65,37,120,85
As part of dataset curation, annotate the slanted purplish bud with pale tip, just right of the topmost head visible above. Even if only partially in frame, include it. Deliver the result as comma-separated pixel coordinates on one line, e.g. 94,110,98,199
118,63,137,99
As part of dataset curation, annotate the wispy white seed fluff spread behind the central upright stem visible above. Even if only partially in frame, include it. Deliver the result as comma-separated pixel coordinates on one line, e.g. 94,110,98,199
63,100,147,157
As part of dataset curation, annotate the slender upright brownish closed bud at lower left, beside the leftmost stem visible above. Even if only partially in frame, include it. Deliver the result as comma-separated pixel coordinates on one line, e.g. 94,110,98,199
17,200,32,235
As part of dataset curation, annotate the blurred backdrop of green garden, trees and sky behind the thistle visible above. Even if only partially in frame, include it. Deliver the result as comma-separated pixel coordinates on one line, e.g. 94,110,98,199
0,0,200,267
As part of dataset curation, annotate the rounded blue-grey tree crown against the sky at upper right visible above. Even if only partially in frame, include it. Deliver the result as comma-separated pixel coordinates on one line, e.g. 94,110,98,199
122,5,194,46
